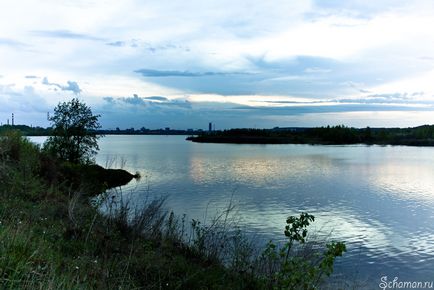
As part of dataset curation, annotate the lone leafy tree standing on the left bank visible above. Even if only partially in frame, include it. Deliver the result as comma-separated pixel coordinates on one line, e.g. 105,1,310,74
44,98,101,163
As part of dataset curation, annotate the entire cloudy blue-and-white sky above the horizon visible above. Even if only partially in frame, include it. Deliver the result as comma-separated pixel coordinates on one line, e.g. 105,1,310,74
0,0,434,129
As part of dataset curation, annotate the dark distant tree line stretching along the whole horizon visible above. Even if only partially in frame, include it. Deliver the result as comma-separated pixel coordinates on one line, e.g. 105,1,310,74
4,121,434,146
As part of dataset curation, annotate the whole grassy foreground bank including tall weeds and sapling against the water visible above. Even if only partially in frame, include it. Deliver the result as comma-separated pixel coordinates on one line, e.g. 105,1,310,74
0,133,345,289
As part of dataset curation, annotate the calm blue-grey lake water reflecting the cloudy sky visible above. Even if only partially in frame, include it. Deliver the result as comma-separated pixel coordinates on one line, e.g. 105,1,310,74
32,136,434,285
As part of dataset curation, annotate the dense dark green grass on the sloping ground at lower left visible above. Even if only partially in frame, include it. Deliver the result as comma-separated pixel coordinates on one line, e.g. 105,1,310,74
0,133,262,289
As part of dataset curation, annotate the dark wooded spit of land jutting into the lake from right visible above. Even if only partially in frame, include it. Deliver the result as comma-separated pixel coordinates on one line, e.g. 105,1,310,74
187,125,434,146
